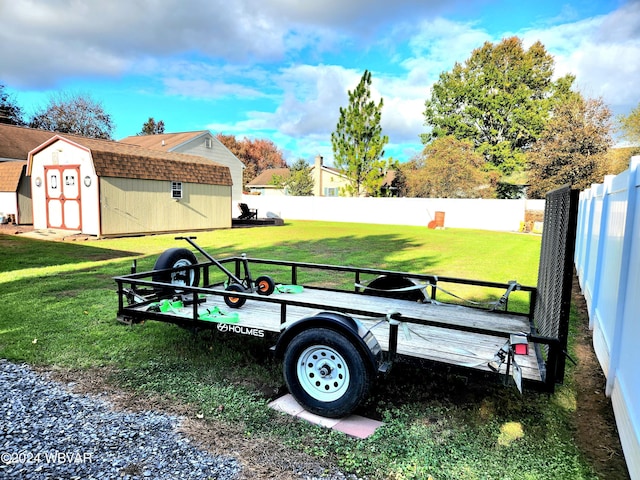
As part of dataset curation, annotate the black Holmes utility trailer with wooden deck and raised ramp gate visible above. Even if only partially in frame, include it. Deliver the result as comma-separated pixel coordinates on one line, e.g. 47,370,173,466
115,188,577,418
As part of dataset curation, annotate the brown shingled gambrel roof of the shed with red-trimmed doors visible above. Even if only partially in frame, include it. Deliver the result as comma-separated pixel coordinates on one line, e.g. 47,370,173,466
28,135,233,185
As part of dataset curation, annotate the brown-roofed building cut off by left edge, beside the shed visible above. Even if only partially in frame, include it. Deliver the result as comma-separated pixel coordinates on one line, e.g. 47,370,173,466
0,123,55,225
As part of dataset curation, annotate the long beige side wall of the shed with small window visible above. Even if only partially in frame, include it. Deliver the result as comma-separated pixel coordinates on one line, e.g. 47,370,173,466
100,177,231,236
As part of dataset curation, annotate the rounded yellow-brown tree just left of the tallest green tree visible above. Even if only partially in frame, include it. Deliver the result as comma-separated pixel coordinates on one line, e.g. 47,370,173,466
400,135,495,198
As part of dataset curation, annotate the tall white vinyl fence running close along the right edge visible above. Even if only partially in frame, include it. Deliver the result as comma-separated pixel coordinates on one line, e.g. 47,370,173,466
575,157,640,480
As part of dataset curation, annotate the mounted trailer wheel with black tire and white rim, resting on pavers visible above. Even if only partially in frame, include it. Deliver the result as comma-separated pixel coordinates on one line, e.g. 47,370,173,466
283,328,373,418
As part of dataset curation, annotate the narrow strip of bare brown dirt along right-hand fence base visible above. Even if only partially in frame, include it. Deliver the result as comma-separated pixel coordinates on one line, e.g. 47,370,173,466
573,278,630,480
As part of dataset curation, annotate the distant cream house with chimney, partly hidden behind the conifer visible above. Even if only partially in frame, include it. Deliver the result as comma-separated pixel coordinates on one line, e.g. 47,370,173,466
247,155,349,197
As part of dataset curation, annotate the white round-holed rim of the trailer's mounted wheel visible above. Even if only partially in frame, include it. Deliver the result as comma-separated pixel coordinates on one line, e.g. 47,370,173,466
296,345,350,402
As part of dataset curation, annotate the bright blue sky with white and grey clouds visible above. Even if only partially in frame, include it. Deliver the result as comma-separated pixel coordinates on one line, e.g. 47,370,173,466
0,0,640,163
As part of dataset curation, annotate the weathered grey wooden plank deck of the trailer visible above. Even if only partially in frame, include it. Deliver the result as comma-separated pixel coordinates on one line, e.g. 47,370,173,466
128,288,542,382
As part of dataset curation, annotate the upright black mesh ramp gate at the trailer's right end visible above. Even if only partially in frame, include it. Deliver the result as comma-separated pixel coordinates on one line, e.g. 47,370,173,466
534,186,579,382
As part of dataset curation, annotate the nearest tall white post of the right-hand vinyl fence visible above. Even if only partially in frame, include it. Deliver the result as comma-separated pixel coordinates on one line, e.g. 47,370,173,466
605,157,640,396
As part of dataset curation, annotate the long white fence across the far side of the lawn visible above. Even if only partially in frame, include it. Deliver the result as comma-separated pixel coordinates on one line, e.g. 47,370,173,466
241,195,544,232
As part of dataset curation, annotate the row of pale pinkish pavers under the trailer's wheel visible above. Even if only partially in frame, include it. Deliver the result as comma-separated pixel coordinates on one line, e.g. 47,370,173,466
269,393,383,438
